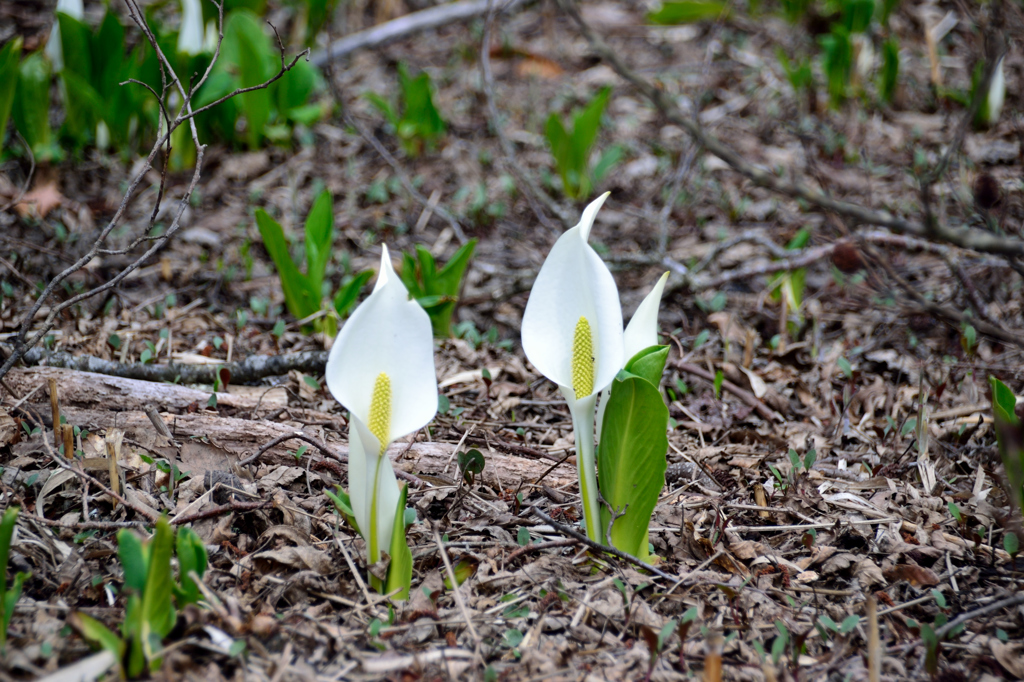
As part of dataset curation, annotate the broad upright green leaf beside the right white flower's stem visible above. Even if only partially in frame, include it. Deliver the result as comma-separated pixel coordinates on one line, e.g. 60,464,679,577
597,376,669,558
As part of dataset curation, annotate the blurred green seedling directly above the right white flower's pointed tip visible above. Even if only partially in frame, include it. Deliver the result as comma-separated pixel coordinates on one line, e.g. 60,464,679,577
544,87,623,200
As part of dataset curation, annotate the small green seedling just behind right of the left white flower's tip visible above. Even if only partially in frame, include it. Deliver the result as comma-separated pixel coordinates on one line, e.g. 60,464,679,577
398,240,476,339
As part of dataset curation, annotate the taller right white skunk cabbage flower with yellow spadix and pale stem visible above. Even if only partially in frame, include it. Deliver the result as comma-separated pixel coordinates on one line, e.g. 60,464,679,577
522,193,624,542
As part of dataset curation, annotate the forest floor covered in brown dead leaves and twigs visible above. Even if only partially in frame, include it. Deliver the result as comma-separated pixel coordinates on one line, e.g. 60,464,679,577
0,1,1024,682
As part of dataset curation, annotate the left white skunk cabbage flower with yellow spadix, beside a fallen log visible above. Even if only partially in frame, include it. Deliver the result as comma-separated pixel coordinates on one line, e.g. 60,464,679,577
327,246,437,563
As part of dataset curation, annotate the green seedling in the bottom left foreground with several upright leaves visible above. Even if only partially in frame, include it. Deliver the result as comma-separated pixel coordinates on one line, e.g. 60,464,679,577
69,517,207,678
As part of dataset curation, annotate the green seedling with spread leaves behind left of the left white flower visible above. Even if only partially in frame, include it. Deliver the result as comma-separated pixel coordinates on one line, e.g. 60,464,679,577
256,190,373,336
